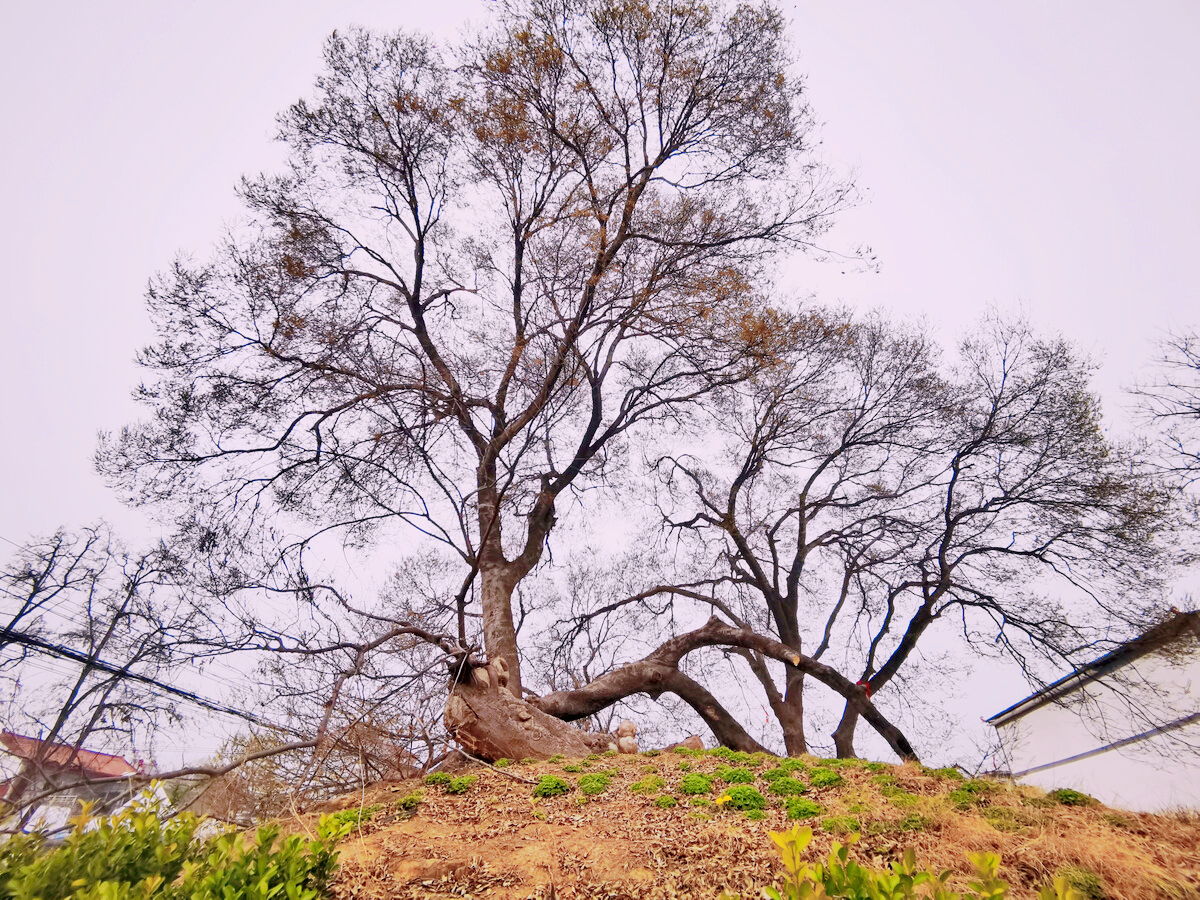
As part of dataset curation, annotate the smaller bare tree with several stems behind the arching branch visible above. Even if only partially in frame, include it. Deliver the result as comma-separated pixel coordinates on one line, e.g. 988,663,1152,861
638,314,1169,756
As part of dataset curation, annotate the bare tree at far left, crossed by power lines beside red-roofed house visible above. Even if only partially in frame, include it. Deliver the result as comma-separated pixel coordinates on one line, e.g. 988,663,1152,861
0,524,203,825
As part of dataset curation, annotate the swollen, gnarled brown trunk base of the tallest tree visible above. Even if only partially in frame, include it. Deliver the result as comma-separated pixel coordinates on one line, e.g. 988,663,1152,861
445,660,617,762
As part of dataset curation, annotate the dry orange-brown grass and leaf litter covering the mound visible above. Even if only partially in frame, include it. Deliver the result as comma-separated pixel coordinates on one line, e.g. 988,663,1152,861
295,754,1200,900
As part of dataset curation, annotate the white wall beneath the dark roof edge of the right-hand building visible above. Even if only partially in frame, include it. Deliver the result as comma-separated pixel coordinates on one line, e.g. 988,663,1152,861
997,638,1200,811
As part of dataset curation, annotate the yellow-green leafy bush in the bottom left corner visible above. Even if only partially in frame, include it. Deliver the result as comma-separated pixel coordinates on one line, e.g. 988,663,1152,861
0,804,350,900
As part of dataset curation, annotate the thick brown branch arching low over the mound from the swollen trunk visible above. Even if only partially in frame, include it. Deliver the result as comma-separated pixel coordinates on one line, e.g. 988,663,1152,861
533,616,917,760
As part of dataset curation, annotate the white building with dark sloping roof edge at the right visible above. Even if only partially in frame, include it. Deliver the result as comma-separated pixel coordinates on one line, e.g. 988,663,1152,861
988,612,1200,811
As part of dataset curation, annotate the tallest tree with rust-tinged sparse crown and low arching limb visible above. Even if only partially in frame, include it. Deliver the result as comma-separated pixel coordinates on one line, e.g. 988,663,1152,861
101,0,911,755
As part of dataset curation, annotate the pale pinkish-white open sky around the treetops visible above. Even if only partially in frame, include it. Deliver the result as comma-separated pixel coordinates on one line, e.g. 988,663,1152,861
0,0,1200,768
